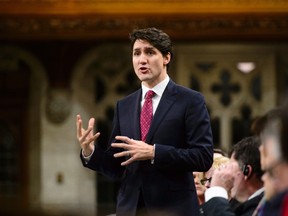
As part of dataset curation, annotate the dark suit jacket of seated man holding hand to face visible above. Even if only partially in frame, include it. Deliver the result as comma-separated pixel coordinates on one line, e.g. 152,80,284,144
200,192,264,216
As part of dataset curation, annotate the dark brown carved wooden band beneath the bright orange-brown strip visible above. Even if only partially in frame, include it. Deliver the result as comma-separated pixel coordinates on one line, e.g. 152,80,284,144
0,14,288,40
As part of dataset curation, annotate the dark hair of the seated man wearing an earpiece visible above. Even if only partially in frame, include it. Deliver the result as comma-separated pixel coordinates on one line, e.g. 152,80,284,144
231,136,263,180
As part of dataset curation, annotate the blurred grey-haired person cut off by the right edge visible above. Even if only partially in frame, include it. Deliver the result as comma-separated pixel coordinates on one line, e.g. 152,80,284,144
254,106,288,216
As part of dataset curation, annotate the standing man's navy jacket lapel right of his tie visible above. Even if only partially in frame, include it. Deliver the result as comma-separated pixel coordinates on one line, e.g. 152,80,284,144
146,80,177,143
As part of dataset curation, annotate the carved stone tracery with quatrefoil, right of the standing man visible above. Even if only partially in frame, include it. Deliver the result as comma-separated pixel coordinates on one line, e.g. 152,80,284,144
176,44,277,152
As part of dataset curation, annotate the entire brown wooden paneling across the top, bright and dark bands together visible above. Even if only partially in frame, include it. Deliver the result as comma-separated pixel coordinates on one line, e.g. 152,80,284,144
0,0,288,40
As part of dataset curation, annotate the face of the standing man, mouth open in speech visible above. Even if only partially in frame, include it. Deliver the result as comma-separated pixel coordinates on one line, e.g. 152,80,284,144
132,40,170,88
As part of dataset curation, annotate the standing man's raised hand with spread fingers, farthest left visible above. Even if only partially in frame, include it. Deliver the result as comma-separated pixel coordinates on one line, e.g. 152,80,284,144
76,115,100,156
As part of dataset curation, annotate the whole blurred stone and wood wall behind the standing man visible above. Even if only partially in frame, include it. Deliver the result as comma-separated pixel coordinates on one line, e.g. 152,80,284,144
0,0,288,216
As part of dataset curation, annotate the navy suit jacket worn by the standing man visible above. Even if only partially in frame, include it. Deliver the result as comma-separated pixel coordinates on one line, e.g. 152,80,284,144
82,80,213,216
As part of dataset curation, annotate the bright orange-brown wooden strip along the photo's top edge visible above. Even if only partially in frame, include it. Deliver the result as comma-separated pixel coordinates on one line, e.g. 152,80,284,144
0,0,288,15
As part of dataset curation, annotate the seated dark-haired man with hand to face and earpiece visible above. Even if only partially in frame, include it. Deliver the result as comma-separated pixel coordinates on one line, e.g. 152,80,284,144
200,136,264,216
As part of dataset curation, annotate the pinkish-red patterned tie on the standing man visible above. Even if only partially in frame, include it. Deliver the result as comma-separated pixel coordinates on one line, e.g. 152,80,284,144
140,90,155,141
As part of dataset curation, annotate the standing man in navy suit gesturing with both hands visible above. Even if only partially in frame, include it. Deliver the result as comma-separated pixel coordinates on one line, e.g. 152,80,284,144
76,28,213,216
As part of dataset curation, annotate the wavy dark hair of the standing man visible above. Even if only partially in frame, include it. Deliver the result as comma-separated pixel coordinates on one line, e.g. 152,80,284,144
129,27,173,69
